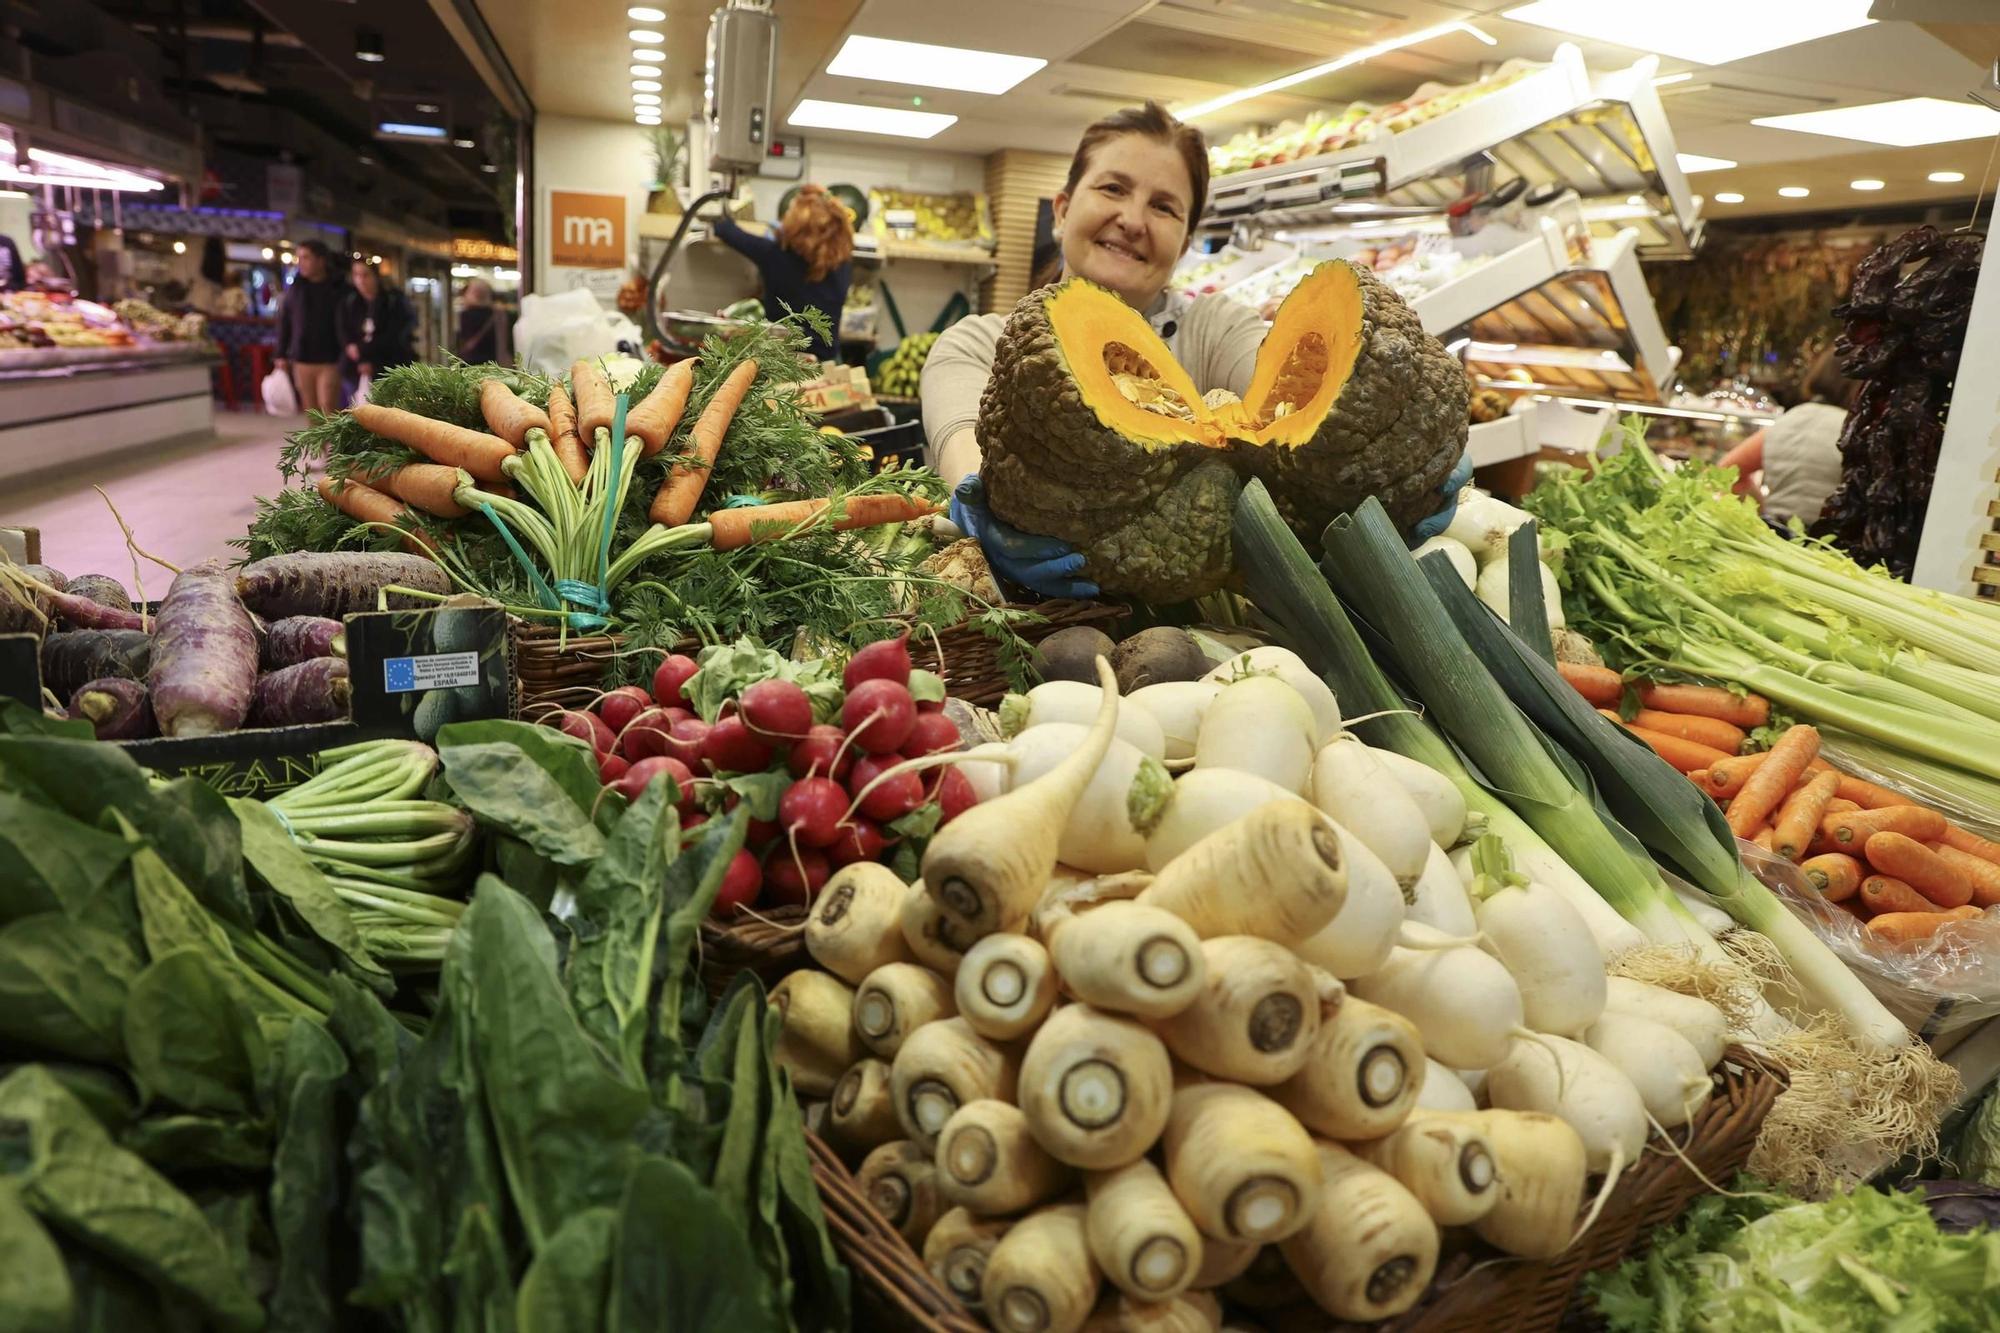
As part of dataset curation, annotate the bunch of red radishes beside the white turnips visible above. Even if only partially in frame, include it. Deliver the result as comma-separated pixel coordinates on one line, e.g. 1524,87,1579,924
550,634,978,917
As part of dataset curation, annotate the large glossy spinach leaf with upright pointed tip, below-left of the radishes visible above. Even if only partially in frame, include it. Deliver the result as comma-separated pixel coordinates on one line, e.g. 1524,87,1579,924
460,875,652,1251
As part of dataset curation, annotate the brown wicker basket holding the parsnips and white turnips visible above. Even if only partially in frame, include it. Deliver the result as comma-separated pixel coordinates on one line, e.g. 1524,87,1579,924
788,1047,1786,1333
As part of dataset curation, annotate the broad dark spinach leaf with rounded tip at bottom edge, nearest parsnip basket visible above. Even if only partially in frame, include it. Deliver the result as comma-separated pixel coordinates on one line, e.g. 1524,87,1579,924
606,1157,784,1333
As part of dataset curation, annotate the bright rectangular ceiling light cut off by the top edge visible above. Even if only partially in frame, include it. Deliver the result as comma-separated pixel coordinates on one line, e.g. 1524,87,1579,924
1502,0,1874,64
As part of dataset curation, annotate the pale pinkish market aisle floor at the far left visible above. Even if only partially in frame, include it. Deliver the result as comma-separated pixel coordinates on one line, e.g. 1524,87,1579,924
0,410,306,576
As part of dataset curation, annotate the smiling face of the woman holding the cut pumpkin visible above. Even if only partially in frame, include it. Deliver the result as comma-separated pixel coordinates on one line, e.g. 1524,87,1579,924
1054,134,1194,310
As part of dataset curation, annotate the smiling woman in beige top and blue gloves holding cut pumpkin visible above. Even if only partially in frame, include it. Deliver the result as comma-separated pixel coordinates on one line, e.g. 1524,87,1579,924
920,102,1470,596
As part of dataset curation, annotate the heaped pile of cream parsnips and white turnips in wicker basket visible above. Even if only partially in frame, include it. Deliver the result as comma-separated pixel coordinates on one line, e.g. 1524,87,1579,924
772,648,1724,1333
